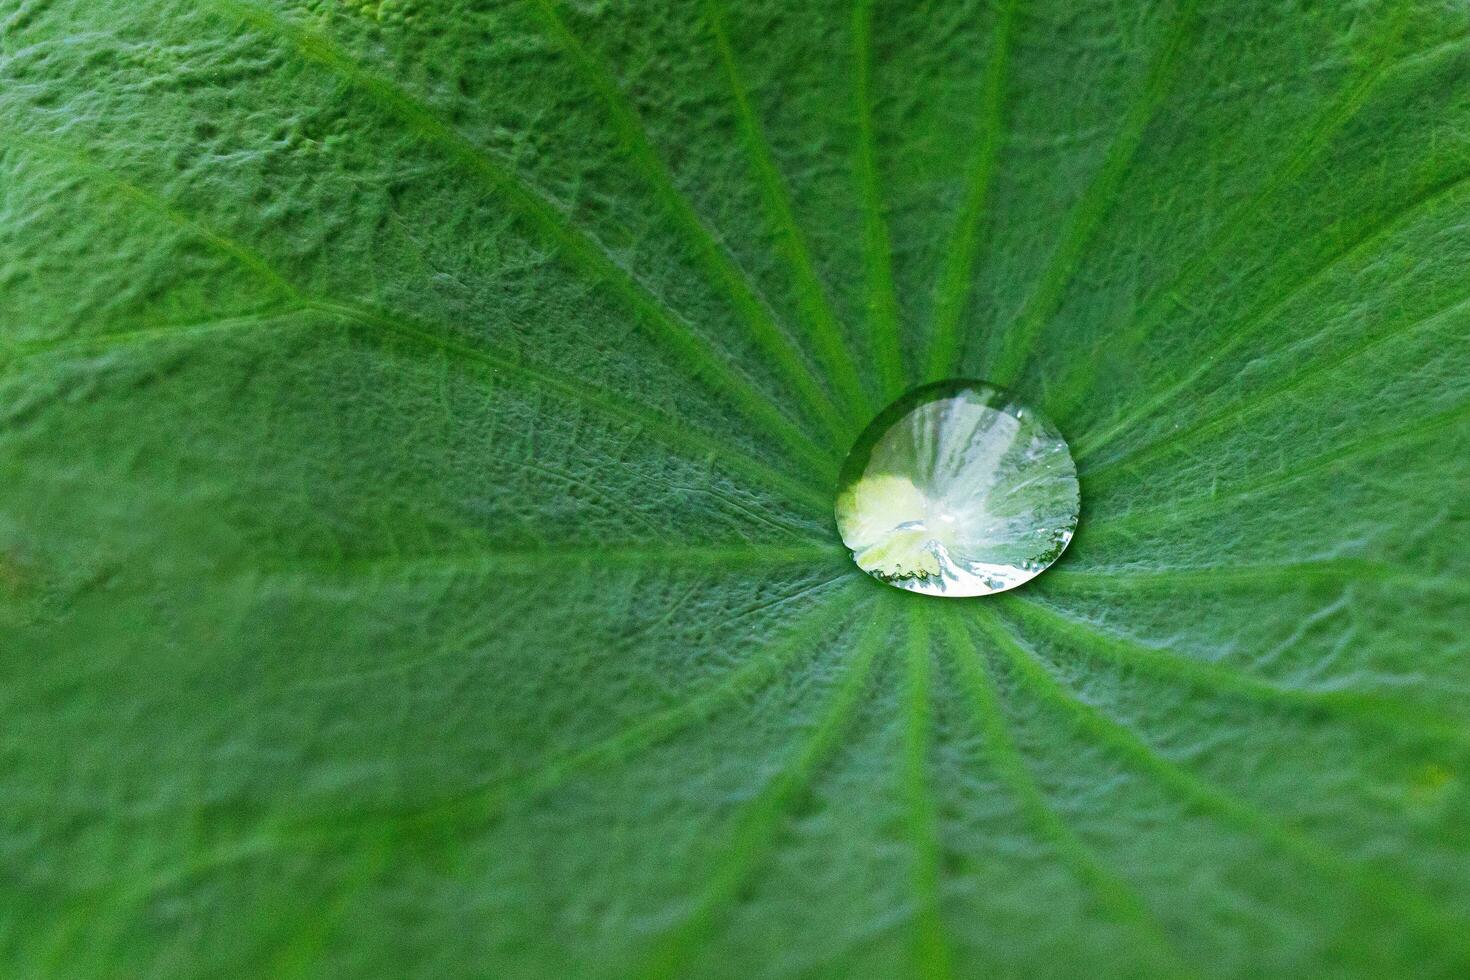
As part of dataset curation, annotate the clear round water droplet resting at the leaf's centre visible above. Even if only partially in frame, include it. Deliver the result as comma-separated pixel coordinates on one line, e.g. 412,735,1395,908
836,381,1080,597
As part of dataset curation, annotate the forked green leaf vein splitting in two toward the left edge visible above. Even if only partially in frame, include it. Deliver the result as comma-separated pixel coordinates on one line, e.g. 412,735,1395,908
6,134,831,513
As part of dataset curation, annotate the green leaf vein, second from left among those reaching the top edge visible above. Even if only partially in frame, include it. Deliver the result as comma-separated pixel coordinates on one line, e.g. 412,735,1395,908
532,0,853,448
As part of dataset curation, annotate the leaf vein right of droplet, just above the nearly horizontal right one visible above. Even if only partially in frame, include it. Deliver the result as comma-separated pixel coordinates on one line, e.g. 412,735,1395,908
1088,401,1470,545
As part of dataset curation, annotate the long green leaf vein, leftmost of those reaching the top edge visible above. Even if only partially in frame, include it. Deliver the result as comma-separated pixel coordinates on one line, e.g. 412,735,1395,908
210,0,832,473
